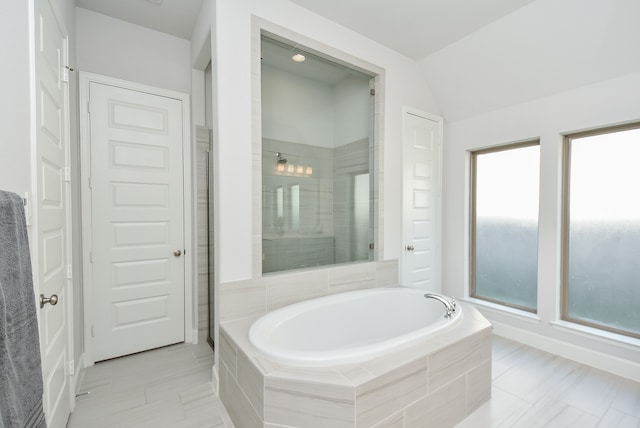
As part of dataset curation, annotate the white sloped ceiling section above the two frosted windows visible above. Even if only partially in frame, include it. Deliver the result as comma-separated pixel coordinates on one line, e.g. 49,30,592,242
420,0,640,121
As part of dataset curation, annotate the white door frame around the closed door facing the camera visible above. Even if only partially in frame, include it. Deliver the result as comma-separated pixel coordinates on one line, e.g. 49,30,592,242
78,71,192,367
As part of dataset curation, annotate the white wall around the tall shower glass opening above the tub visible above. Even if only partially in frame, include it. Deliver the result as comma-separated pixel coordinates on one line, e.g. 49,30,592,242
194,0,439,282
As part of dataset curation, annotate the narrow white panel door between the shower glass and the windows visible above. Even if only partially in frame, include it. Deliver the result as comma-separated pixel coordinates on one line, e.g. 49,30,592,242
402,111,442,291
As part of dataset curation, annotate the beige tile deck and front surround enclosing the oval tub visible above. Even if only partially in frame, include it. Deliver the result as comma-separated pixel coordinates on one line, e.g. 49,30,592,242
218,303,491,428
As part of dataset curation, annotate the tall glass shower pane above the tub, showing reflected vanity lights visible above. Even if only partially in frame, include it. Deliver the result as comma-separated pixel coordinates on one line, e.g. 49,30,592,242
261,34,376,273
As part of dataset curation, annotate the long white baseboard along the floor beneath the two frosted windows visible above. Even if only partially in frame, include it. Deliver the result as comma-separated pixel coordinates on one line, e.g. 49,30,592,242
491,320,640,382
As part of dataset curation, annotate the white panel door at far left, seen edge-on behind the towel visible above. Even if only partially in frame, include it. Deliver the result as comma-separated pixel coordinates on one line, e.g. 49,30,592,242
32,0,73,428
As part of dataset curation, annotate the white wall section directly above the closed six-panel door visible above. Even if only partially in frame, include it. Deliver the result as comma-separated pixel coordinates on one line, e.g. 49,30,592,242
76,8,191,94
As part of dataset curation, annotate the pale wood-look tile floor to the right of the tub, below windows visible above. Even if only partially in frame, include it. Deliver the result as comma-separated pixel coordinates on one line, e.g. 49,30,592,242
456,336,640,428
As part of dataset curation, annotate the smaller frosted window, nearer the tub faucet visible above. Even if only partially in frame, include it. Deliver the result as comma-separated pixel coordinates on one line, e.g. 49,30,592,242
469,141,540,312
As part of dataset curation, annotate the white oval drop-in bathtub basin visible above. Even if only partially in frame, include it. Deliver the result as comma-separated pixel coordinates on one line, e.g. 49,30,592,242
249,287,462,367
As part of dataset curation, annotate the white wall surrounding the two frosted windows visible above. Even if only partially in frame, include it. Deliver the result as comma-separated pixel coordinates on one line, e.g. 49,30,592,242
442,73,640,379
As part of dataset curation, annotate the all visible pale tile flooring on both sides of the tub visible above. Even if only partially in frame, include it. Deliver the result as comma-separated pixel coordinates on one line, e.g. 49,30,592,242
67,336,640,428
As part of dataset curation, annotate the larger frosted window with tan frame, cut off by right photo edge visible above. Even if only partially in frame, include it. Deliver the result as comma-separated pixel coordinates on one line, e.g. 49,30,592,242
562,124,640,337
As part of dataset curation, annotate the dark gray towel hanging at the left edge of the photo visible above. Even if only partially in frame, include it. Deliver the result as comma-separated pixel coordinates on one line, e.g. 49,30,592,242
0,191,46,428
